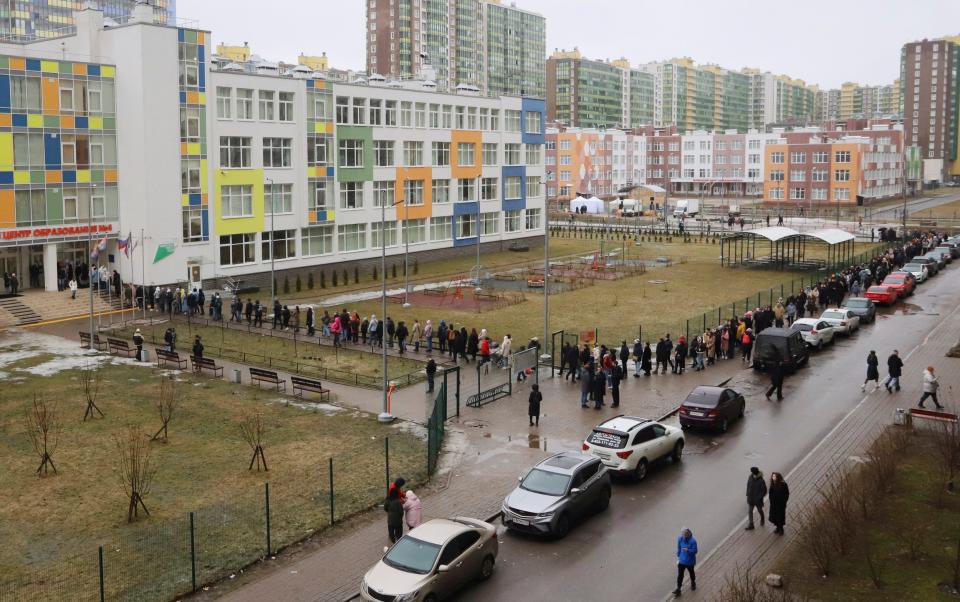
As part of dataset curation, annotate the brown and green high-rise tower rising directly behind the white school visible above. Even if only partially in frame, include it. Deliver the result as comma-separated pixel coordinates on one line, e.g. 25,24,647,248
367,0,546,98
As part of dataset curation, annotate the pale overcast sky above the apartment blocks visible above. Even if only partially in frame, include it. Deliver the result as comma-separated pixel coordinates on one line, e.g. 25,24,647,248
177,0,960,88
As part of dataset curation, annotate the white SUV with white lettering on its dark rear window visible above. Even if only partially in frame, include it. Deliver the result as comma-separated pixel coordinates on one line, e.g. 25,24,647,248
583,416,685,481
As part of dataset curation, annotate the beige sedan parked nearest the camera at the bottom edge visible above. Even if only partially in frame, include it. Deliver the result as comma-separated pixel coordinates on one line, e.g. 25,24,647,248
360,517,498,602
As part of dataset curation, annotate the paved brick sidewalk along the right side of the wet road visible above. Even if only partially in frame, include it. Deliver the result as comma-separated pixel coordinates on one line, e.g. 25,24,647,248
684,298,960,600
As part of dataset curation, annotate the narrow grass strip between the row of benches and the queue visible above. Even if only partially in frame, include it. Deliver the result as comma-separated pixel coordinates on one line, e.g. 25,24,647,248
111,319,424,387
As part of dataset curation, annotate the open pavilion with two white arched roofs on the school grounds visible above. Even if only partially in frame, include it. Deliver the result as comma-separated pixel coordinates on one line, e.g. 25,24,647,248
720,226,854,270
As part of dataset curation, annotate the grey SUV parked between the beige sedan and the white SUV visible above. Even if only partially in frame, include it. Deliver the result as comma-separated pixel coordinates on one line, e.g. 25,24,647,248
500,452,611,538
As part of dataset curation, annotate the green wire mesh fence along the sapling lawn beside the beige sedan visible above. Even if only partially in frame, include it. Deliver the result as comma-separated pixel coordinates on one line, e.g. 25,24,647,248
0,436,428,602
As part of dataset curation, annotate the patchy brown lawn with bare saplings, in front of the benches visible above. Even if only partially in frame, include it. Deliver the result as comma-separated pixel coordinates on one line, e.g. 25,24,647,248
0,332,426,600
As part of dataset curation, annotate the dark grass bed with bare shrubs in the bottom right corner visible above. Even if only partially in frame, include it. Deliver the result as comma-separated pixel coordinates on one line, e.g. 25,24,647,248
775,435,960,602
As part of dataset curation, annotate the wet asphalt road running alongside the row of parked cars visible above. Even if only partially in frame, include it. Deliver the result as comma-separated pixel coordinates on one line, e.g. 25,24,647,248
458,268,960,602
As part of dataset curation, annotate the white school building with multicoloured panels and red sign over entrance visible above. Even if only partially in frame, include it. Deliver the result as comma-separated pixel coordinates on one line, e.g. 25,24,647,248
0,4,545,290
